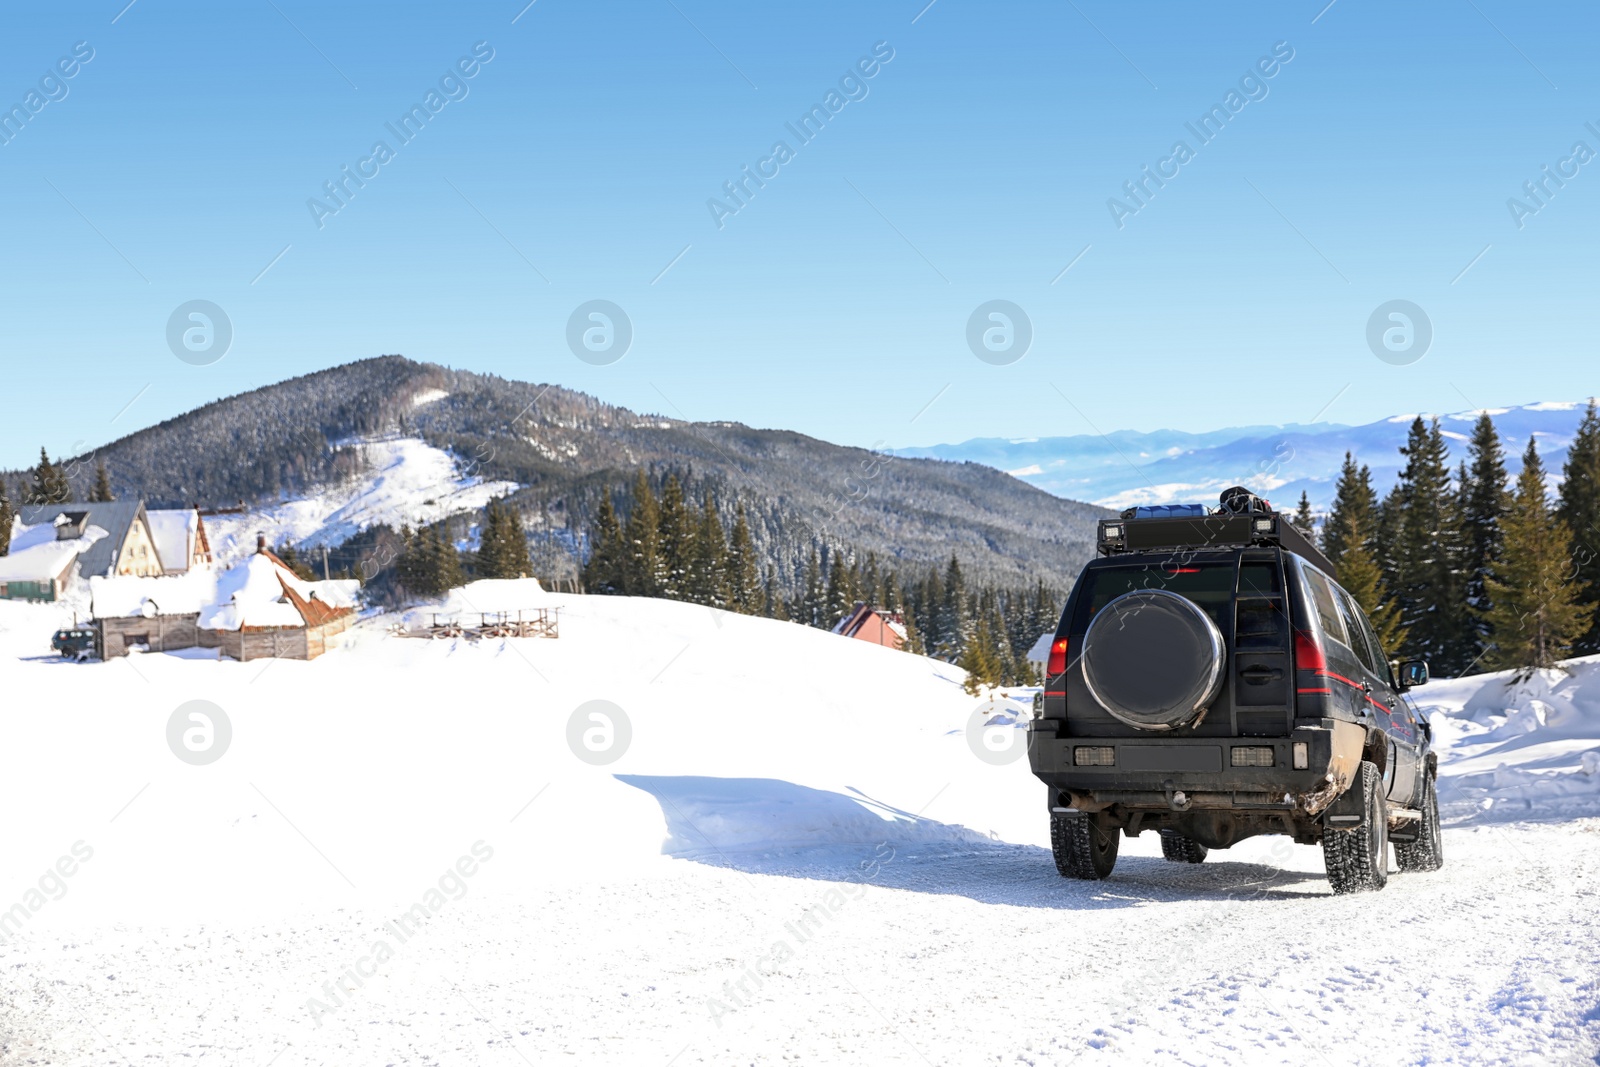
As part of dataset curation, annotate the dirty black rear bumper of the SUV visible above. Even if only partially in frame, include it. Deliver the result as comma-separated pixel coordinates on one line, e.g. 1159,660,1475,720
1027,720,1365,814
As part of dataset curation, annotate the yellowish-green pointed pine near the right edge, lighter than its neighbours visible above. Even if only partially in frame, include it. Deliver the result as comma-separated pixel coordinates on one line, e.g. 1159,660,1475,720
1488,437,1590,678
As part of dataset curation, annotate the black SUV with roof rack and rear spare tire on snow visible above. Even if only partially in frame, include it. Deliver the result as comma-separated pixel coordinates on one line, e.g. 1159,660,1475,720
1027,488,1443,893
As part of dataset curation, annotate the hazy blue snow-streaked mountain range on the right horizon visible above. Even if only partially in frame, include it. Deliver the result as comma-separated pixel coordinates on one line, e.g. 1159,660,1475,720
896,400,1587,510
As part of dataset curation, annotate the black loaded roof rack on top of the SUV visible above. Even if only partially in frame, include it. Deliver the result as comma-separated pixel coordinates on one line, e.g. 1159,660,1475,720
1096,486,1338,577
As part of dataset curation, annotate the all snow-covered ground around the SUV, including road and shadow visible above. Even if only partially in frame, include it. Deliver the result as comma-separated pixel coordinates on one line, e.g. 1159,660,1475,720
0,589,1600,1067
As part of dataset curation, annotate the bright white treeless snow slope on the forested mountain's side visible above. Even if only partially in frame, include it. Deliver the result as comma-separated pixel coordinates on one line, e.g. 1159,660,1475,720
196,435,517,561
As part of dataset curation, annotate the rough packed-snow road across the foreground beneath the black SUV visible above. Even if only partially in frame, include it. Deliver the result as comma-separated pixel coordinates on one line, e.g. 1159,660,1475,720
3,821,1600,1065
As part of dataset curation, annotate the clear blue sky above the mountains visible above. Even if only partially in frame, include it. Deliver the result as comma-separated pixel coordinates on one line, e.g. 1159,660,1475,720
0,0,1600,466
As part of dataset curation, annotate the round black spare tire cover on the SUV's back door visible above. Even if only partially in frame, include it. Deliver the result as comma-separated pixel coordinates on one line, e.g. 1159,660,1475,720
1082,589,1226,729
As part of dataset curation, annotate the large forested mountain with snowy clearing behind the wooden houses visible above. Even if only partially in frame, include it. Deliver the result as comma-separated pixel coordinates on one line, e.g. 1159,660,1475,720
0,355,1107,589
